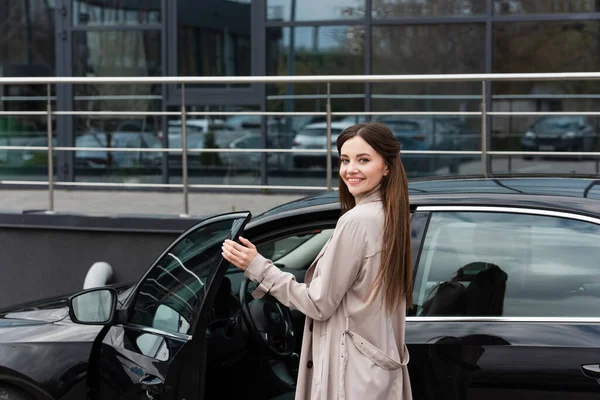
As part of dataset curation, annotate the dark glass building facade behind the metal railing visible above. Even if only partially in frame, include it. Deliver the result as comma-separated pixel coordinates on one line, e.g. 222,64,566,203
0,0,600,191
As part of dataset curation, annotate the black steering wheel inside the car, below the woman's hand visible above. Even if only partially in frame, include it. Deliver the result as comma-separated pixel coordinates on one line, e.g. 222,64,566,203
240,277,296,358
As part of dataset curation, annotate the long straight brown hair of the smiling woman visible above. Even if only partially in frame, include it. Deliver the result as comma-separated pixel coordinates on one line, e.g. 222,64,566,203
337,123,412,312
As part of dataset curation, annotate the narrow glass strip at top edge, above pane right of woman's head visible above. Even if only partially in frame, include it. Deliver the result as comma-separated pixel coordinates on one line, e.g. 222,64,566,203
371,0,486,18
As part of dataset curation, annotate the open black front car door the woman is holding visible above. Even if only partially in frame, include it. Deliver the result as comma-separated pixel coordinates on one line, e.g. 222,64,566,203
88,212,250,400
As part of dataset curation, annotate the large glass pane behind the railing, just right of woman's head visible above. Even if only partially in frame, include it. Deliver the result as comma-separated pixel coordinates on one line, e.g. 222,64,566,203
371,24,485,177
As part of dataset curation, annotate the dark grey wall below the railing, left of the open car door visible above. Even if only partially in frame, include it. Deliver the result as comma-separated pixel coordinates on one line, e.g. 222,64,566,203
0,214,204,307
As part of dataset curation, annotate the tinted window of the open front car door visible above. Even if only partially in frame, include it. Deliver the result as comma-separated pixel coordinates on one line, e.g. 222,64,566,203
129,219,246,334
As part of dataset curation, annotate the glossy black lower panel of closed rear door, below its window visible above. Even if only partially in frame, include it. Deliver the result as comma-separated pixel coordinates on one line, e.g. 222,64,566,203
406,317,600,400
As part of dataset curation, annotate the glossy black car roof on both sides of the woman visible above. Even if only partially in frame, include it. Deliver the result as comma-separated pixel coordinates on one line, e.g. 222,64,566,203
256,177,600,223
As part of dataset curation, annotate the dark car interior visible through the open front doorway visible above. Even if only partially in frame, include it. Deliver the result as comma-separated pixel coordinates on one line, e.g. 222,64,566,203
200,227,333,399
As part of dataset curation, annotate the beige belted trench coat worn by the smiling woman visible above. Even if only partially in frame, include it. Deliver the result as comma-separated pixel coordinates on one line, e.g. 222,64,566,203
245,192,412,400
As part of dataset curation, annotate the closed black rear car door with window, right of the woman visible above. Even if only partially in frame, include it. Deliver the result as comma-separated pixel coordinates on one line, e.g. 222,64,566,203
406,207,600,400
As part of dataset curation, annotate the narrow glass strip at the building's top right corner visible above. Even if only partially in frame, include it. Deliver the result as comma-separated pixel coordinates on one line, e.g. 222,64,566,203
494,0,600,14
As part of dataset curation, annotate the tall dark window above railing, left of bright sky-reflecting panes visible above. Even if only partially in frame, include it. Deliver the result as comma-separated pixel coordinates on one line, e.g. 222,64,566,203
177,0,252,87
